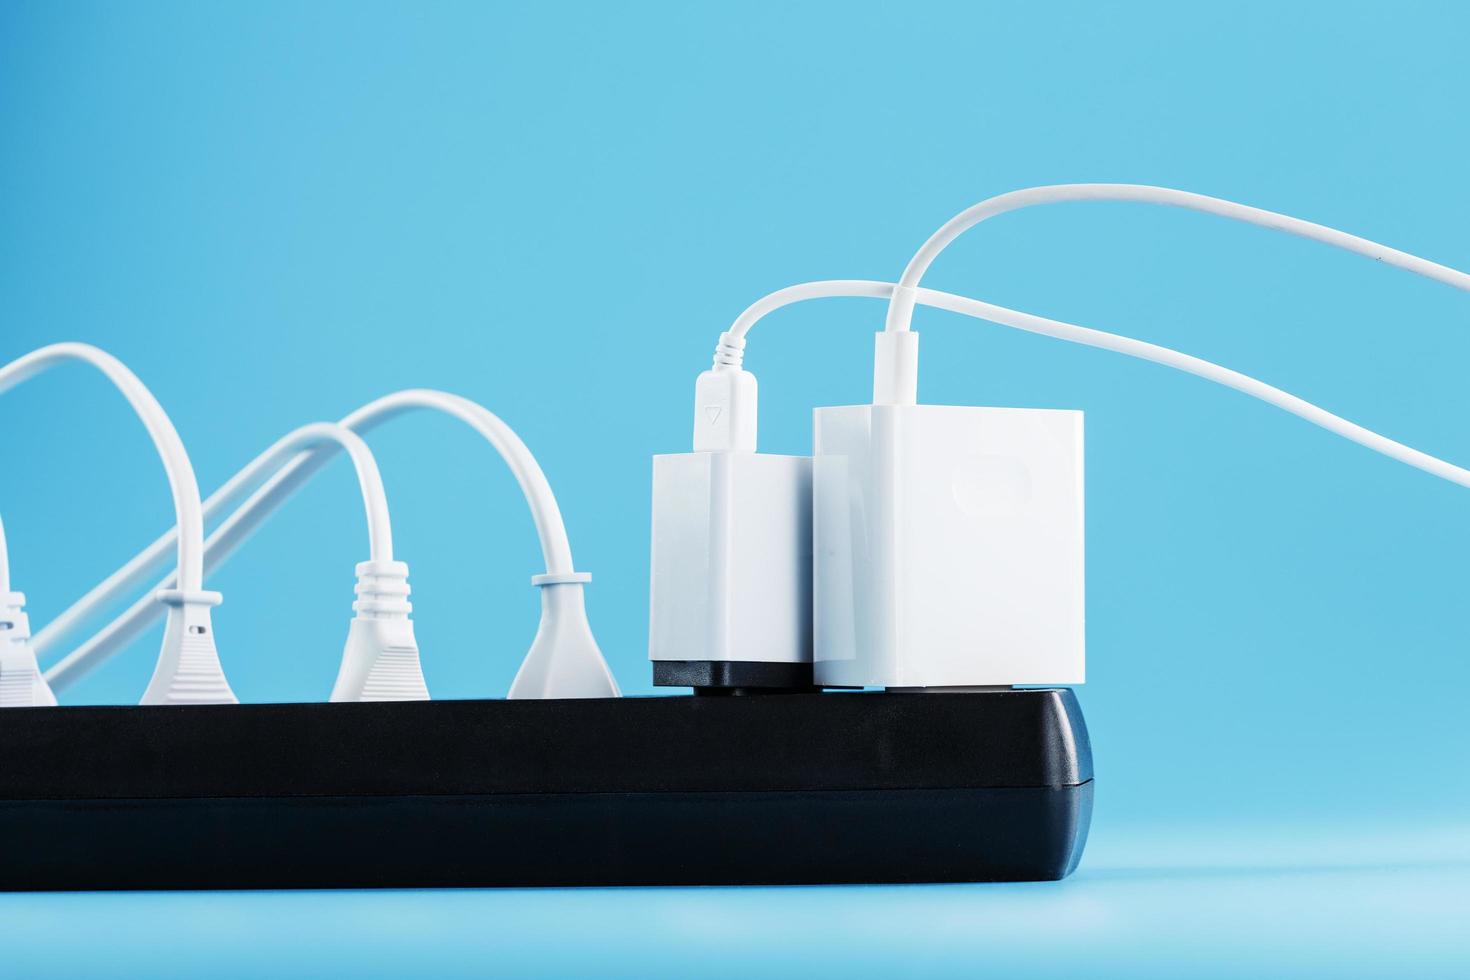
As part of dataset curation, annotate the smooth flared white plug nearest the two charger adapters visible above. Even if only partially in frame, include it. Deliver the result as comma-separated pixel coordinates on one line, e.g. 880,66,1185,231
507,572,622,698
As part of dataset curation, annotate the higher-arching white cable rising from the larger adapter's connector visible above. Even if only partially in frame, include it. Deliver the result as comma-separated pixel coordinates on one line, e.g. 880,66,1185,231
883,184,1470,331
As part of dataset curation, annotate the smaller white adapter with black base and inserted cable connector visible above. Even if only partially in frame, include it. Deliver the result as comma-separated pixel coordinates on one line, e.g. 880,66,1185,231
648,366,811,692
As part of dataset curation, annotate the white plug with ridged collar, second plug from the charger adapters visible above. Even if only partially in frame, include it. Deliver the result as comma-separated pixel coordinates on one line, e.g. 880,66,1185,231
332,561,429,701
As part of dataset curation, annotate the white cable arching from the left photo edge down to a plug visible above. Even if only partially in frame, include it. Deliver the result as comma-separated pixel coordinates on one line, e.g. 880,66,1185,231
0,344,204,592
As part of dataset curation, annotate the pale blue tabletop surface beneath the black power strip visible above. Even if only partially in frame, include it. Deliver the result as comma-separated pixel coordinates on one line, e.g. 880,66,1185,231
0,824,1470,977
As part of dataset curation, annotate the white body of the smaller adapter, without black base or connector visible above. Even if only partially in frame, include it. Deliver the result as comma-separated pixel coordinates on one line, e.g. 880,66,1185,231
648,453,811,663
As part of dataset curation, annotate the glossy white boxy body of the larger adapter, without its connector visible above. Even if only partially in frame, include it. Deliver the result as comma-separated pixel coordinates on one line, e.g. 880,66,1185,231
813,406,1083,688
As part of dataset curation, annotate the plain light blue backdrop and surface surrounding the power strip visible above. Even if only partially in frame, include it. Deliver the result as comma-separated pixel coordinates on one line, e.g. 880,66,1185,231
0,3,1470,976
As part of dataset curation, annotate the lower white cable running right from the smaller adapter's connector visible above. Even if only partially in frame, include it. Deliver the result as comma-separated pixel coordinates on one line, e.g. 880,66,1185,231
729,279,1470,486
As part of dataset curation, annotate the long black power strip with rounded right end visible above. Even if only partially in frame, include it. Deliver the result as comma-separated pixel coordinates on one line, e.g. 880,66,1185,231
0,689,1092,889
